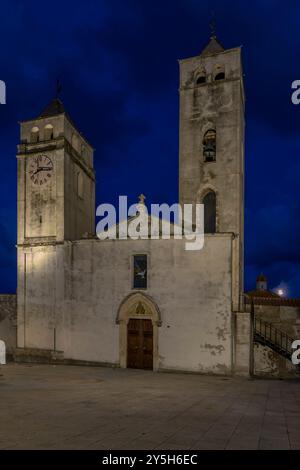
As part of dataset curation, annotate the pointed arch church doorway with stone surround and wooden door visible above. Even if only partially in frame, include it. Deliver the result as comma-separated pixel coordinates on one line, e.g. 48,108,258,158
116,292,161,370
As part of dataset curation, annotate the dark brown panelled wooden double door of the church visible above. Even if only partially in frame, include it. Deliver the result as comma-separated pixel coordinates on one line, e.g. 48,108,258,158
127,318,153,369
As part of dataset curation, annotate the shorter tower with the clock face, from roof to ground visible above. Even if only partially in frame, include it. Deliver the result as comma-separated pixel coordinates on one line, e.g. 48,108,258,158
17,98,95,351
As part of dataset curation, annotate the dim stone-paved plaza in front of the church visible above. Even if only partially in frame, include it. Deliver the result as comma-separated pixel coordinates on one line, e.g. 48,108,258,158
0,364,300,450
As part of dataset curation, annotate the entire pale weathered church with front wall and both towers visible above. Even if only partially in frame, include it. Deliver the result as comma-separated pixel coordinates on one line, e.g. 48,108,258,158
17,37,251,374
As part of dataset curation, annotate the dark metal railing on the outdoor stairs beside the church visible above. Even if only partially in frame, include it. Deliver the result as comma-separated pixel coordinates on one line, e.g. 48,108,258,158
254,317,294,359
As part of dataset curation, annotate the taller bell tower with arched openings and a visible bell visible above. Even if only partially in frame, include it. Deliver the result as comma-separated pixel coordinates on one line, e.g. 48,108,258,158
179,33,245,303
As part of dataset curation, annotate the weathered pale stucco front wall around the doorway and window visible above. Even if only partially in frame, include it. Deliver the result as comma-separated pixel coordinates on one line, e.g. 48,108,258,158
18,235,237,373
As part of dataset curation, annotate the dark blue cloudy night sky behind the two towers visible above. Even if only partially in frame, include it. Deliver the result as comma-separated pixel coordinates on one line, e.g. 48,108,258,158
0,0,300,297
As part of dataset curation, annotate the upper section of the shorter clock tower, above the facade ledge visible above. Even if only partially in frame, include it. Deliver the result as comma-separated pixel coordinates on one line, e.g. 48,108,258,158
17,98,95,246
